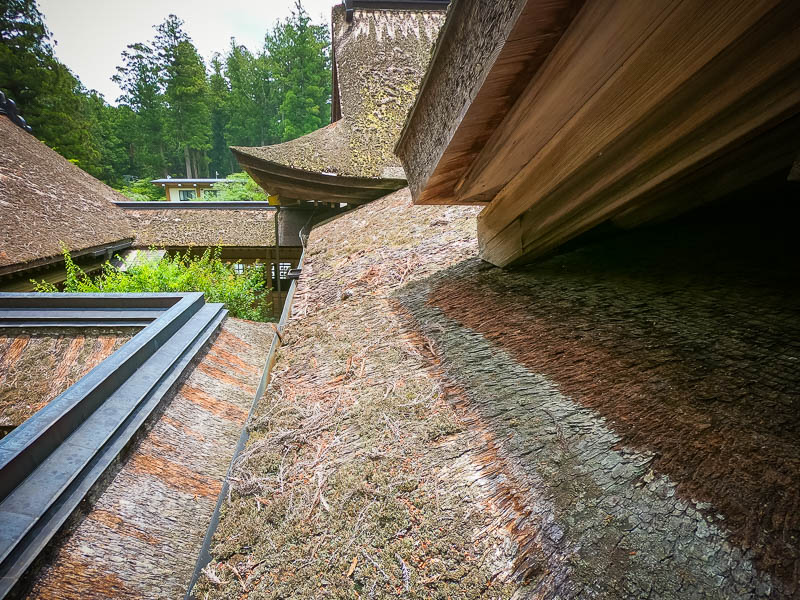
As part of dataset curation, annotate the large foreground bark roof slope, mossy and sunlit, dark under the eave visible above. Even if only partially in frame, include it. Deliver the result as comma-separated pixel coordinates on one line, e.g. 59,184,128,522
197,185,800,599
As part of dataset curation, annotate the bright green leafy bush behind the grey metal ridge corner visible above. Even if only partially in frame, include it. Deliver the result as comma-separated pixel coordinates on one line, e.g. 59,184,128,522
33,247,271,321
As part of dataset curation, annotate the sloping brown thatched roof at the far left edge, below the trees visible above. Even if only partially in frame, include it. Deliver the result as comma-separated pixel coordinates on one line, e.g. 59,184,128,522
0,116,133,272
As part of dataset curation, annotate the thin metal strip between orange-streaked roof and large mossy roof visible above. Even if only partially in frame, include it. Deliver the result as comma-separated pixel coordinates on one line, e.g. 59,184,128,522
184,249,306,600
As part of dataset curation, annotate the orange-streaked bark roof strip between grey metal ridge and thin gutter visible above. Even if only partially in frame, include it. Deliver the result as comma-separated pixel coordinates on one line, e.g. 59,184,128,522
29,317,274,598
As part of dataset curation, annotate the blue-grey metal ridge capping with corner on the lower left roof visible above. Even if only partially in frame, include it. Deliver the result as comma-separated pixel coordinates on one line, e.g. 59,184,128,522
0,292,227,598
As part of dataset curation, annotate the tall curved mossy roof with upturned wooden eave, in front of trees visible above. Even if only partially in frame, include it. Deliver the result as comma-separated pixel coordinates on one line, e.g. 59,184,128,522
233,3,446,202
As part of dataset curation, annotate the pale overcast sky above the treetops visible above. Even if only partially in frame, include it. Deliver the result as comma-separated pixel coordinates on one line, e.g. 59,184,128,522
39,0,338,103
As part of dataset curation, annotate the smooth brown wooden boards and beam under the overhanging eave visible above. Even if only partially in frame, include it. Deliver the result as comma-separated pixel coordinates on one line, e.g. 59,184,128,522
476,0,800,266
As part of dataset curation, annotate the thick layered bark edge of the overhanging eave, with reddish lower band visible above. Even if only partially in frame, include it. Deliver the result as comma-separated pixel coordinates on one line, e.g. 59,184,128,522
395,0,584,206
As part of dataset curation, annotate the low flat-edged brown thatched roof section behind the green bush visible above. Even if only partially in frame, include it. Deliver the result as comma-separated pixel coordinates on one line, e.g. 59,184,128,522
125,209,275,248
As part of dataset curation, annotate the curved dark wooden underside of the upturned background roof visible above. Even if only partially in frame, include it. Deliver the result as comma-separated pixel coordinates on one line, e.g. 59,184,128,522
231,148,407,204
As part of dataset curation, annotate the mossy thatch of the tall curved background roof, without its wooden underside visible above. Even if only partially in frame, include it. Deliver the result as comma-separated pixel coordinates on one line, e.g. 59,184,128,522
233,5,445,192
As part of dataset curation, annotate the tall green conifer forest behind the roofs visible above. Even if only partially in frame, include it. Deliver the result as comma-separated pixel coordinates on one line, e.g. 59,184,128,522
0,0,331,188
